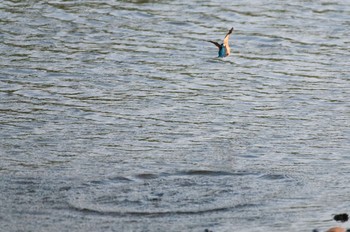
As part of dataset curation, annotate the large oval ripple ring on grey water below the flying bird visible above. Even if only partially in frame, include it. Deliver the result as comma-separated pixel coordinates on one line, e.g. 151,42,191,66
66,171,292,214
